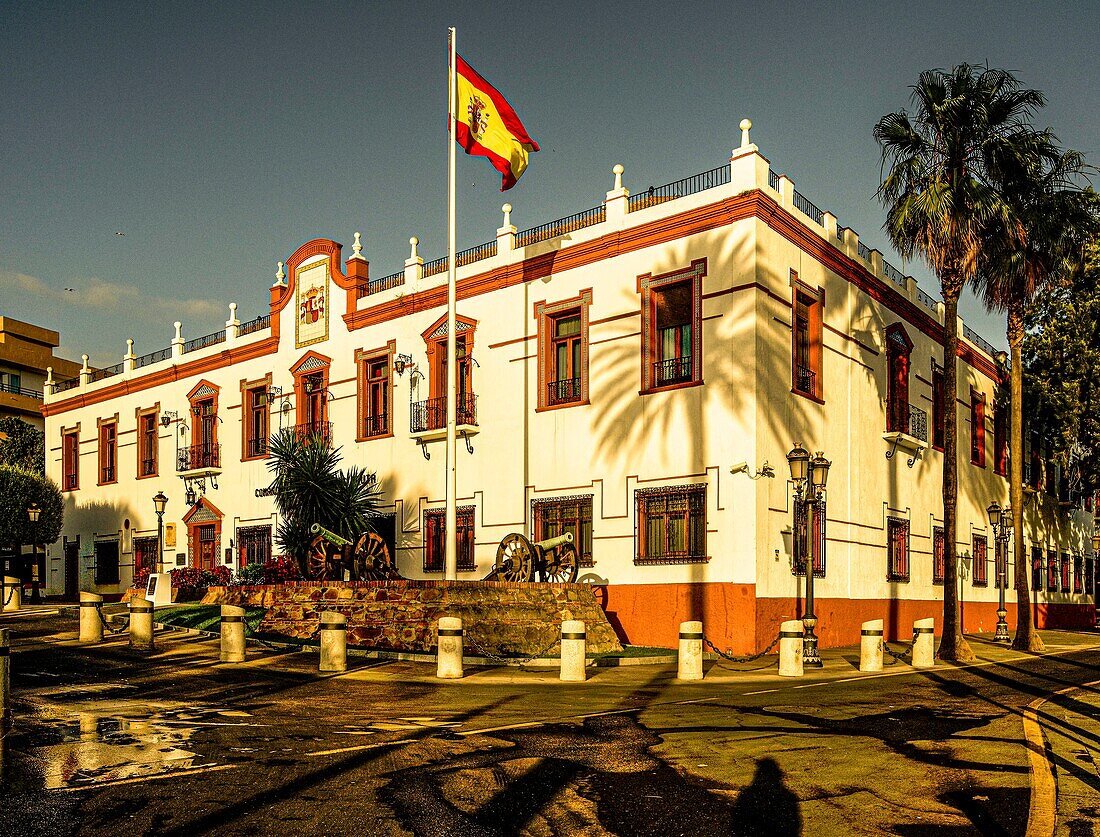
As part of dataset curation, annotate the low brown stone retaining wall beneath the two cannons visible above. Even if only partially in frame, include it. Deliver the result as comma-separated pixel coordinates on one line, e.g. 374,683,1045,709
202,581,623,654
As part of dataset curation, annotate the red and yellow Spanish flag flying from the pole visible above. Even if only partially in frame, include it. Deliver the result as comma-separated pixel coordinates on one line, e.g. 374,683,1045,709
454,55,539,191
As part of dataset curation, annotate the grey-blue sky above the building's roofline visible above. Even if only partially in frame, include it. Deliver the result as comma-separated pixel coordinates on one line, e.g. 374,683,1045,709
0,0,1100,365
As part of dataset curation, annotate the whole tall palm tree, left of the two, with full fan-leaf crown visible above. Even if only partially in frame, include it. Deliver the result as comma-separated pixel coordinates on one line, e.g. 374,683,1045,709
875,64,1045,662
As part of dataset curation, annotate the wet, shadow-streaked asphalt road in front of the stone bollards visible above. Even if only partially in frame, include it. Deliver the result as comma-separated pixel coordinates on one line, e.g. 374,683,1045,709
0,617,1100,837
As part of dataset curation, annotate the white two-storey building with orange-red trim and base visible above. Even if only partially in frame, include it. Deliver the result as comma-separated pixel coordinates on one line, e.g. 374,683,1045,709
43,124,1095,652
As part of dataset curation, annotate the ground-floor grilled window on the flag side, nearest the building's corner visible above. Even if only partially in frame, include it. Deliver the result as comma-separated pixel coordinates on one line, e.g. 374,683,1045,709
634,485,707,564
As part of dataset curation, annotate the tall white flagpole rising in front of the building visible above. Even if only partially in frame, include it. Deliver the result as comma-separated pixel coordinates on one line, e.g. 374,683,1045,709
443,26,459,580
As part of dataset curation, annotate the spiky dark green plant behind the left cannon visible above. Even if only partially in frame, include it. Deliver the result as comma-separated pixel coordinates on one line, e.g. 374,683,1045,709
267,429,381,575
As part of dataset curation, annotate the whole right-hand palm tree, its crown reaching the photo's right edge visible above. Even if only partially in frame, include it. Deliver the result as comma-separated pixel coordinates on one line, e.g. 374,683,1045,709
976,147,1098,651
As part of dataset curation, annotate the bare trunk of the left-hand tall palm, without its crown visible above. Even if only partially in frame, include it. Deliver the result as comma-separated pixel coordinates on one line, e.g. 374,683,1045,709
939,276,976,662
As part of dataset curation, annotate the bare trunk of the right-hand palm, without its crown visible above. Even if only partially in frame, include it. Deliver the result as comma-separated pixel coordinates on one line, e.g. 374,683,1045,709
1008,301,1046,652
